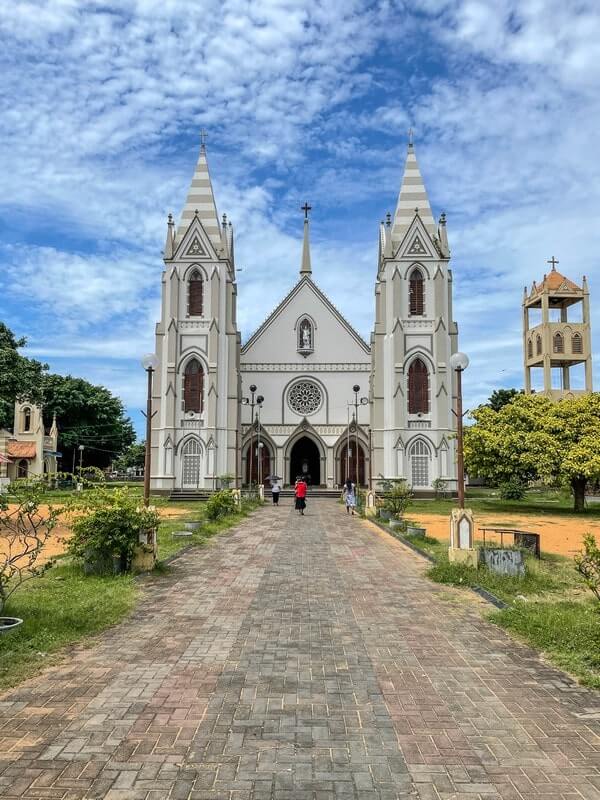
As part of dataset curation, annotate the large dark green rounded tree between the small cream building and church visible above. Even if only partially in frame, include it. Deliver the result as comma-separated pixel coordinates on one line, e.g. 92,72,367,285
43,375,135,470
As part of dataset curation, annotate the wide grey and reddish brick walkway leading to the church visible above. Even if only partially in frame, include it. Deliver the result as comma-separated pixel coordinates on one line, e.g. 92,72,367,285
0,501,600,800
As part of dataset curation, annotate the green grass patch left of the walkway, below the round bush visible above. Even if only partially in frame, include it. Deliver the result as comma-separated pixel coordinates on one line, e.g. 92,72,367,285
0,564,137,689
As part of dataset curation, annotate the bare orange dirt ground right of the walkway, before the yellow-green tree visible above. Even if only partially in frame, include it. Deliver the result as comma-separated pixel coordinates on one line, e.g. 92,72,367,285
407,511,600,556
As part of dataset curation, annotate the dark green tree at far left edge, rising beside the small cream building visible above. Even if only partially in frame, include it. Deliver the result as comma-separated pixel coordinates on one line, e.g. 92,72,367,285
0,322,48,428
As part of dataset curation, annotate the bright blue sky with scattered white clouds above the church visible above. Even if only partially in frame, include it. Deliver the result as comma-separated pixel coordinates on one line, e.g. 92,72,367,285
0,0,600,438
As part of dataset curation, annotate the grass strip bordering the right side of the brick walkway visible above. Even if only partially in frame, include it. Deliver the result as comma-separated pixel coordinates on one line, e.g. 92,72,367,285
378,520,600,689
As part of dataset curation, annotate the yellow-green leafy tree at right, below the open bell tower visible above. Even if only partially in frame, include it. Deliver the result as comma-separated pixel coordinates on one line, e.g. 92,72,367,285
464,393,600,511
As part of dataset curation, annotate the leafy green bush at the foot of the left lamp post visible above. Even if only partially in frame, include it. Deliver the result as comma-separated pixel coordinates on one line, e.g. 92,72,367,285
68,486,159,570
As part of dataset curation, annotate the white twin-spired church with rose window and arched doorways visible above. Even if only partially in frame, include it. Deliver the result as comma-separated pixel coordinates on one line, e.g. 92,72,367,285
151,138,458,493
